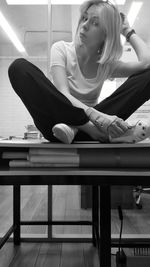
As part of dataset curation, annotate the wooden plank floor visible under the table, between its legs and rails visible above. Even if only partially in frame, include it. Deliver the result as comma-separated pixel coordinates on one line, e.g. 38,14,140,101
0,186,150,267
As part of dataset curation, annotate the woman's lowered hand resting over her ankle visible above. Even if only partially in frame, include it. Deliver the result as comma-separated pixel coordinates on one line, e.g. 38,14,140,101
86,108,131,138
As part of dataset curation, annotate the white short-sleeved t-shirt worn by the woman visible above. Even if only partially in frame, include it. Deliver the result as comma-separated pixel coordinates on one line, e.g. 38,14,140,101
50,41,115,106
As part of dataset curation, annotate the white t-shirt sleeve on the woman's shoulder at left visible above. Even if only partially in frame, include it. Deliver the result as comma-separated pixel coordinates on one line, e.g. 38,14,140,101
50,41,66,69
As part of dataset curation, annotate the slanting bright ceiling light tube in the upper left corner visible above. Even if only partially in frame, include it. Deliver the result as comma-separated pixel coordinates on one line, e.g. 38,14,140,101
0,11,27,55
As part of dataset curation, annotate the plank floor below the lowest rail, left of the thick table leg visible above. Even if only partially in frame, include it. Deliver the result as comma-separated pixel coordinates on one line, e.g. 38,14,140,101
0,243,103,267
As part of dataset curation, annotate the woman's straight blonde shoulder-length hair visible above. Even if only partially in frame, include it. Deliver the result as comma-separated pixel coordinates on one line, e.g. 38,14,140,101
76,0,122,64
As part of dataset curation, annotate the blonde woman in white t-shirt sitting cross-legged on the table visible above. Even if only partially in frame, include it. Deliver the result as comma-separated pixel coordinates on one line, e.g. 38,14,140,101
9,0,150,143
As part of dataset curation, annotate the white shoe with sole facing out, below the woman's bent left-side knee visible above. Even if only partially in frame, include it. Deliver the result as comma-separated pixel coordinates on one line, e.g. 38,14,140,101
52,123,78,144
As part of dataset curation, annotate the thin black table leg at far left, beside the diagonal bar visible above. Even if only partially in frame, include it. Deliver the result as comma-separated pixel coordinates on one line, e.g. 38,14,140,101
13,185,20,245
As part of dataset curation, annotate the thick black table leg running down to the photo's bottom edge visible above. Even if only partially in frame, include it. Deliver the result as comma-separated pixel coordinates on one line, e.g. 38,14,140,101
100,185,111,267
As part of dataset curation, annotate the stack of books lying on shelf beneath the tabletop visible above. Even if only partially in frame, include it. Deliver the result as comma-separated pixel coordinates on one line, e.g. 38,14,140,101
2,148,79,167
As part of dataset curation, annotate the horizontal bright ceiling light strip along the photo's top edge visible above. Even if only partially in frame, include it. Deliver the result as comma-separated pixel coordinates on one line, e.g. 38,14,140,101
6,0,126,5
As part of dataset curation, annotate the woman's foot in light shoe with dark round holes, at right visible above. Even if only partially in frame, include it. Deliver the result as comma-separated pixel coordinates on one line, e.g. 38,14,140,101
109,121,150,143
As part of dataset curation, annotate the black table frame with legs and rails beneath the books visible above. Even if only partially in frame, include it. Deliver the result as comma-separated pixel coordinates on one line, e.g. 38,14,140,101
0,141,150,267
